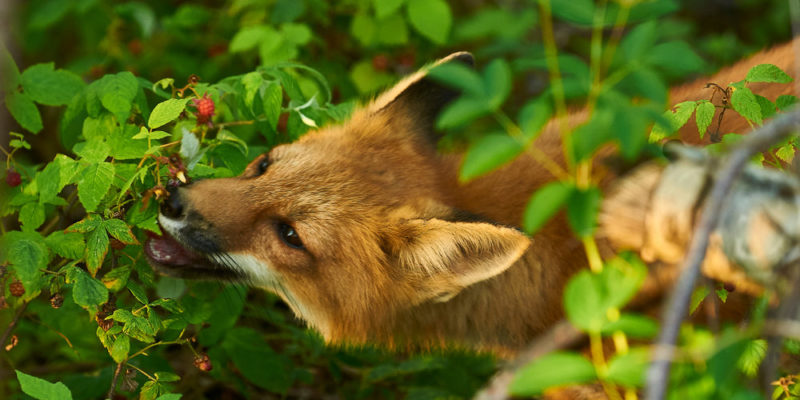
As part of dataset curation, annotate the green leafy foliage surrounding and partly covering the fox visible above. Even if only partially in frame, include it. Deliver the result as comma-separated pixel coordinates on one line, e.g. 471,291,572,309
0,0,797,400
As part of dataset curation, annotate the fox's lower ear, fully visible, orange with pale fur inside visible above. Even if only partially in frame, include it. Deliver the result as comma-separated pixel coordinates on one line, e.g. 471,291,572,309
384,219,530,303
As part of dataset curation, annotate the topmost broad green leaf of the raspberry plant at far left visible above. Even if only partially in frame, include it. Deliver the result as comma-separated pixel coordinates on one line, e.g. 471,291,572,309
22,63,86,106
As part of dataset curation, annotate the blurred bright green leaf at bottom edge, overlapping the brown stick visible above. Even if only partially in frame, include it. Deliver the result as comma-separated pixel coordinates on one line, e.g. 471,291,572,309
508,352,596,396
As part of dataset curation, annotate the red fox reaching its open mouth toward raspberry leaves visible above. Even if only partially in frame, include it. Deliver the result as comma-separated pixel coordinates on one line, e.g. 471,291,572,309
145,41,797,353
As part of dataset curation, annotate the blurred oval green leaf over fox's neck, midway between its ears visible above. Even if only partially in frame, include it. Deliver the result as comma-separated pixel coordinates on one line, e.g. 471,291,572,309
458,133,524,182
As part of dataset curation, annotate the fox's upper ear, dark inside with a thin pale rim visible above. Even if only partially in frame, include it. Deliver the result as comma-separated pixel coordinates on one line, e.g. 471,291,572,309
368,51,475,139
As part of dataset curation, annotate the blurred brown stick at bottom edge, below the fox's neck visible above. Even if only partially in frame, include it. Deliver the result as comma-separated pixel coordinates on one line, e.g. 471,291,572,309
474,320,586,400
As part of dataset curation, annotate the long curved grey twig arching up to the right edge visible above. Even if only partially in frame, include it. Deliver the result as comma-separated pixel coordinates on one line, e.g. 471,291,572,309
645,107,800,400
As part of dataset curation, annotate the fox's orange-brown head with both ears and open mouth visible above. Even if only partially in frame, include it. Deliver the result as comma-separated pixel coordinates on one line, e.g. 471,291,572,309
145,53,530,343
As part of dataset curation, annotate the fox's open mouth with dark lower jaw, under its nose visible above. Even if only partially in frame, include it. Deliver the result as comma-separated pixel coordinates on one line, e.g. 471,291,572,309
144,226,240,280
